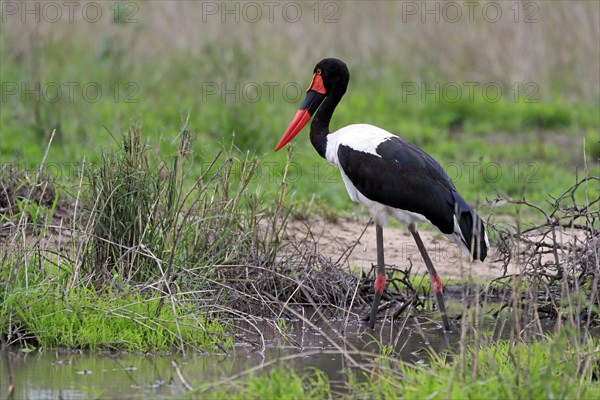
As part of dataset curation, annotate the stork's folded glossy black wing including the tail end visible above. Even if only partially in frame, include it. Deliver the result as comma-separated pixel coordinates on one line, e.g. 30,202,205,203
338,137,487,261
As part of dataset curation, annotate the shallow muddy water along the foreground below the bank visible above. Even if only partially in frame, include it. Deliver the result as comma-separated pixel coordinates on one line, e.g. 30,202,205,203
0,302,548,399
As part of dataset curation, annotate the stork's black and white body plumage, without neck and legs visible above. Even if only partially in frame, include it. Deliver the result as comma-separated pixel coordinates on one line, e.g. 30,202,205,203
326,125,487,261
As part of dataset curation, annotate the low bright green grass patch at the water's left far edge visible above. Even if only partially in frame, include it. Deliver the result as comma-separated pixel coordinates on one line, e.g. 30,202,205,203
3,285,233,351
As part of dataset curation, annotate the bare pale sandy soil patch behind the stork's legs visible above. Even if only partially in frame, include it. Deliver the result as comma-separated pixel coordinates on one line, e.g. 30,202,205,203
288,218,514,280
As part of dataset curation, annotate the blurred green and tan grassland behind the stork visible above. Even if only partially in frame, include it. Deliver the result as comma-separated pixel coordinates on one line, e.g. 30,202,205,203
0,1,600,214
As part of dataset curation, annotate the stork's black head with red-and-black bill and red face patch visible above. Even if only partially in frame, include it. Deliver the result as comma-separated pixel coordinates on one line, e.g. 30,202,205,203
275,58,350,151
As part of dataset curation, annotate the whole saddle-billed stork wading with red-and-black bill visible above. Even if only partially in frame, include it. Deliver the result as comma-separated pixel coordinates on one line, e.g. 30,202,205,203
275,58,488,330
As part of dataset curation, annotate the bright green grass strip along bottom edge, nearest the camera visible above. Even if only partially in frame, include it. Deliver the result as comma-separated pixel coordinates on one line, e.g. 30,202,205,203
199,330,600,399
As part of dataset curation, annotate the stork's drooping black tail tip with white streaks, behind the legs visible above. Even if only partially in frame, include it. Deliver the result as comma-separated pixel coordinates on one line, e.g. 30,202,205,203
454,192,488,261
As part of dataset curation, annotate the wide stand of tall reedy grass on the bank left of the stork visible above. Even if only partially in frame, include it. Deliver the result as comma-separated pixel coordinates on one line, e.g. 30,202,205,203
85,128,287,287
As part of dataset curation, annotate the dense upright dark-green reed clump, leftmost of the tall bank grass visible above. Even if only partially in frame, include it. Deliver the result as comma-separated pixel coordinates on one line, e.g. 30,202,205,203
85,128,177,282
